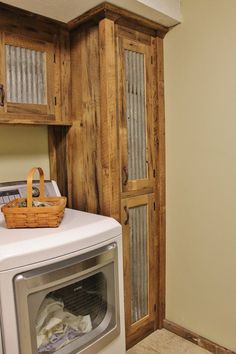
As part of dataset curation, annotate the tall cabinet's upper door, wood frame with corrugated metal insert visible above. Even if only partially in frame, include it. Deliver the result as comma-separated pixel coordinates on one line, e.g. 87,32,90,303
118,37,155,192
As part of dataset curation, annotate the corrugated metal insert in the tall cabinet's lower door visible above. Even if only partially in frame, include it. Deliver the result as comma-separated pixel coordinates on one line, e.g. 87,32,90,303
129,205,148,323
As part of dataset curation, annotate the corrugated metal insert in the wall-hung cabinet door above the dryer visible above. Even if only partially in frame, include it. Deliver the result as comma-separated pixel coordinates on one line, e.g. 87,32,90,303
5,44,47,104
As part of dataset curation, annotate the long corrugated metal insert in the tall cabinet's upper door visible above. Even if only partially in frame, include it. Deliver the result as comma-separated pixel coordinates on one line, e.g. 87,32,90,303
125,49,147,180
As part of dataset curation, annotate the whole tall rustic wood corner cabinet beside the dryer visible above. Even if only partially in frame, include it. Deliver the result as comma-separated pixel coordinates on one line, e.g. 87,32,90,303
68,4,166,347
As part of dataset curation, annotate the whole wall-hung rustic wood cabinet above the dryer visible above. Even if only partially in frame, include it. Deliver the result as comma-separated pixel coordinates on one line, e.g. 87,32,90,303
0,3,70,124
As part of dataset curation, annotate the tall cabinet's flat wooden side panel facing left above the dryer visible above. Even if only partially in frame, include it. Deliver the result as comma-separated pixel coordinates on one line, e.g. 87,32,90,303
68,27,101,213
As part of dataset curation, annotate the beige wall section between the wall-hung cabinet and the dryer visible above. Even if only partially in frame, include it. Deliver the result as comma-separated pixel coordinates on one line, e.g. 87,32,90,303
0,125,49,182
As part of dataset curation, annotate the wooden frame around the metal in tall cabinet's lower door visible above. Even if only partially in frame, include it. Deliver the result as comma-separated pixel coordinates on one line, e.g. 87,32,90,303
121,193,157,340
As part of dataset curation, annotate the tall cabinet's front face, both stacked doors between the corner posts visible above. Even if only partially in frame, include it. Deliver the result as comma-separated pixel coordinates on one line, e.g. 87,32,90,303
117,27,159,347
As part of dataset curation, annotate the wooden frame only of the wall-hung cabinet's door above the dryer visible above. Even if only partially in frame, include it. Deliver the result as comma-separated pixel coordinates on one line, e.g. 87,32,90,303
0,32,56,120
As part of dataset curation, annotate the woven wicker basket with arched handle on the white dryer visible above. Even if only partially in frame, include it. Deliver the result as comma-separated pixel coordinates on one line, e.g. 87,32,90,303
2,167,66,229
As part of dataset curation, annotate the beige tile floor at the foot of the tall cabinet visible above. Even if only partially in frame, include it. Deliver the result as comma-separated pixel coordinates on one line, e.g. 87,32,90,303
127,329,210,354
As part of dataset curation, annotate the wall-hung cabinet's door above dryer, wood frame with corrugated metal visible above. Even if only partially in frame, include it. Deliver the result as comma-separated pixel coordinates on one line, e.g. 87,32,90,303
0,33,56,121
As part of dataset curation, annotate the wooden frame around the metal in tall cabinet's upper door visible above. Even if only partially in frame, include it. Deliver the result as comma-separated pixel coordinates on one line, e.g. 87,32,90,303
117,37,155,192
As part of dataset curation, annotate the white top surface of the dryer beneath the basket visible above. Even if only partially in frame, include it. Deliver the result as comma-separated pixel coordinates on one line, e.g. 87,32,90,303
0,209,121,272
